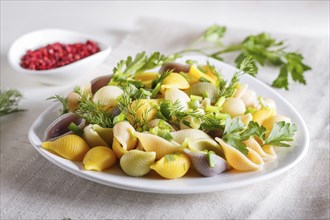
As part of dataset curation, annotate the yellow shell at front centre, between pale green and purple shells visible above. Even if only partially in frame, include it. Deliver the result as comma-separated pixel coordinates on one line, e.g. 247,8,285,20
150,153,191,179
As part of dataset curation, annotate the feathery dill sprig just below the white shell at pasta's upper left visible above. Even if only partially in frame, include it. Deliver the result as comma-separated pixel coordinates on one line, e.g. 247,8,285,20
74,87,114,128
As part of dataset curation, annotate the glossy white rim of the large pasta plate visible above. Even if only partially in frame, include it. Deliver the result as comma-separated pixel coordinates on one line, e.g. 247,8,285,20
28,55,310,194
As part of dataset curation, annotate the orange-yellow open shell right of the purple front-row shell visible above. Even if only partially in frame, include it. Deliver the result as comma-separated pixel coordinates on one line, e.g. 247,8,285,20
215,138,264,171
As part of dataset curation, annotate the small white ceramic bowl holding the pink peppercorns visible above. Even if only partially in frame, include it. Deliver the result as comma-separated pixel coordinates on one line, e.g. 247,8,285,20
8,29,111,85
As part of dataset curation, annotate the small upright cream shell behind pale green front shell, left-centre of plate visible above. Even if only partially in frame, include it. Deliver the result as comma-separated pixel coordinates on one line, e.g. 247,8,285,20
113,121,137,150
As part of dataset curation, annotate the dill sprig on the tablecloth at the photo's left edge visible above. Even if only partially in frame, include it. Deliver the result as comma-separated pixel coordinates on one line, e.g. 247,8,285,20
0,89,23,116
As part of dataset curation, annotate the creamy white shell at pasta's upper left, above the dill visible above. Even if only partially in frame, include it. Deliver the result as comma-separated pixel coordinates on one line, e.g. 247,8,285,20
93,86,124,108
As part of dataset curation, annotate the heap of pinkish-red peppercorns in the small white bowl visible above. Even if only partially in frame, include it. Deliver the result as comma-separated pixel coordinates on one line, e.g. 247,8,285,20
20,40,100,70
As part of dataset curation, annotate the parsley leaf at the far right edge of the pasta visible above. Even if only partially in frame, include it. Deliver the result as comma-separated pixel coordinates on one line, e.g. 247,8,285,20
264,121,297,147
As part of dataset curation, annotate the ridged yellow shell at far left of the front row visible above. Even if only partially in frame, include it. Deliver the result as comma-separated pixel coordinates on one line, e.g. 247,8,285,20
41,134,89,161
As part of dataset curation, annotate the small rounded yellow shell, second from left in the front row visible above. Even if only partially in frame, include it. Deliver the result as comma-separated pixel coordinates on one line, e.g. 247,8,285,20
83,146,116,171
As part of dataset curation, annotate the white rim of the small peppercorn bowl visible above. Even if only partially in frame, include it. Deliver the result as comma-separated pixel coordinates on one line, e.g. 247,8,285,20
7,28,112,75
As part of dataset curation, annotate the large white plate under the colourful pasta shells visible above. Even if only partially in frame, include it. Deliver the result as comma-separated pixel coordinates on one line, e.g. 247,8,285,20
29,56,309,194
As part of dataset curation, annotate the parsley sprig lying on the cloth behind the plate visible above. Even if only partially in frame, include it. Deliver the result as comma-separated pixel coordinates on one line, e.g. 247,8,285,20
176,25,311,90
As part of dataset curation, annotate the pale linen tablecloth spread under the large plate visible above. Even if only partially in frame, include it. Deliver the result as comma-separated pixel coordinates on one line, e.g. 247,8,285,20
1,18,330,219
